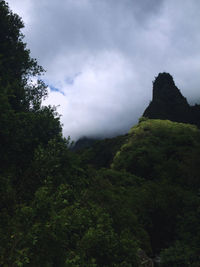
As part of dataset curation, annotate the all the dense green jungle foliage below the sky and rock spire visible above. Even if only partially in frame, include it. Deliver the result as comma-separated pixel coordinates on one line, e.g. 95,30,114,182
0,1,200,267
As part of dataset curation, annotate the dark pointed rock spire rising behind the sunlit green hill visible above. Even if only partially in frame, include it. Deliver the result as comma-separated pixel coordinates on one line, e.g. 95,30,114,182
143,72,200,127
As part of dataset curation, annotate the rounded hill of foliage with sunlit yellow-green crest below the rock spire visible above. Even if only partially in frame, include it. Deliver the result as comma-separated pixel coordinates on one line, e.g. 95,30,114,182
112,120,200,188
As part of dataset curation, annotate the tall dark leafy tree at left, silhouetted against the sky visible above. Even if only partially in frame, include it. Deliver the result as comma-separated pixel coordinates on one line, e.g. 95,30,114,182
0,1,62,176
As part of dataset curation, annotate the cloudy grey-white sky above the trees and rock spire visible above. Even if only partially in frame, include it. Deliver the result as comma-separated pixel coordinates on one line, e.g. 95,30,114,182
8,0,200,140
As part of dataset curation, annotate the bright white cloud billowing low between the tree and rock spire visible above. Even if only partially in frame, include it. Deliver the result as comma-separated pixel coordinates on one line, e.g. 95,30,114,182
43,52,144,139
